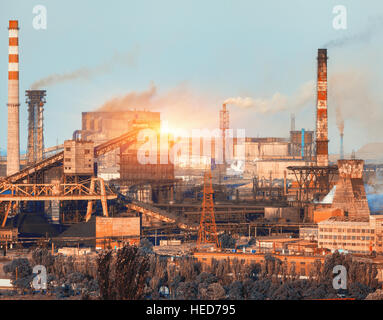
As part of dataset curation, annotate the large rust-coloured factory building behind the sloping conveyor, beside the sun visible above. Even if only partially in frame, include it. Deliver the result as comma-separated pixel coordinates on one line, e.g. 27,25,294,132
80,110,174,181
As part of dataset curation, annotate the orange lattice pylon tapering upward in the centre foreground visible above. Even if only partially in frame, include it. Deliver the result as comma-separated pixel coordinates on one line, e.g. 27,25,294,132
197,170,219,247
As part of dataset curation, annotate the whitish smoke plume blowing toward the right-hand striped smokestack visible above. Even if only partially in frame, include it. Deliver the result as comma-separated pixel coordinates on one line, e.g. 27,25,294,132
224,81,315,114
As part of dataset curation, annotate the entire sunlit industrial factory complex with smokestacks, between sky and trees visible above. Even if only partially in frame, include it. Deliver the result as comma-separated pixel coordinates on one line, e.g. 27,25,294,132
0,16,383,292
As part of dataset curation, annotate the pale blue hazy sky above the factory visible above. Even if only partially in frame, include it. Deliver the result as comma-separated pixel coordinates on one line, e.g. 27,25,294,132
0,0,383,153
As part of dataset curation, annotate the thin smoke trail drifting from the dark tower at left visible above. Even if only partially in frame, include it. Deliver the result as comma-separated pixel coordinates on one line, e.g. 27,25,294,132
31,48,137,90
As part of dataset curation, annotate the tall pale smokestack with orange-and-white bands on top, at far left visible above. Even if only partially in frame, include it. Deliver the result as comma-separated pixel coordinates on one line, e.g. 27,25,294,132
7,20,20,175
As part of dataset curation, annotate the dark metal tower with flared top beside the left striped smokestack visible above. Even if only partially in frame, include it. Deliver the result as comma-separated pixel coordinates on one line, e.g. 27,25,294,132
25,90,46,164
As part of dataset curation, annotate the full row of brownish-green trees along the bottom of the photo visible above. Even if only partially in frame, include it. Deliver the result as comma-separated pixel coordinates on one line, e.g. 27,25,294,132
4,245,379,300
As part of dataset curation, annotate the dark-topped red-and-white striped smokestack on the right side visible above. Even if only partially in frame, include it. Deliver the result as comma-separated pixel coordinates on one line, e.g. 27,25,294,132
316,49,328,166
